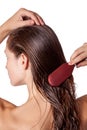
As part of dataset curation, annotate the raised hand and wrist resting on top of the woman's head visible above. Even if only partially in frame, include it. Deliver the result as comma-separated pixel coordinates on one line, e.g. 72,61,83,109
0,8,44,43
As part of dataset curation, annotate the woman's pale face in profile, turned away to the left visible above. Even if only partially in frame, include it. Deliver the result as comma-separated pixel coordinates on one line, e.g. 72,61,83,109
5,46,25,86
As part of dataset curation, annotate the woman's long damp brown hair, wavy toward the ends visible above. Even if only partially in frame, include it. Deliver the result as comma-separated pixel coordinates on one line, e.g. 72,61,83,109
7,25,79,130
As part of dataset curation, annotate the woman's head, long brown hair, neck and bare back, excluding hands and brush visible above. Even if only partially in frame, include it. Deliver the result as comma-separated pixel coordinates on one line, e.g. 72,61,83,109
1,25,80,130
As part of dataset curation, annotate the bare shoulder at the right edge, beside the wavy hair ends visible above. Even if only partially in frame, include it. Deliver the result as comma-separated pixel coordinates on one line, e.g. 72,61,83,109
77,95,87,130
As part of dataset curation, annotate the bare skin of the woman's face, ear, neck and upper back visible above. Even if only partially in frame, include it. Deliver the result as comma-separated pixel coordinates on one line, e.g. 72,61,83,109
0,42,52,130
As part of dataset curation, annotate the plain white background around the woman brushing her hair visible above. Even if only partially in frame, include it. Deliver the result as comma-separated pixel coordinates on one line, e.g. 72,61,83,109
0,0,87,105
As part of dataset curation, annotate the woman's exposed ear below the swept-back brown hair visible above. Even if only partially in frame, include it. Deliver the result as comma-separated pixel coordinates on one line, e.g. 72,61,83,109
18,53,29,69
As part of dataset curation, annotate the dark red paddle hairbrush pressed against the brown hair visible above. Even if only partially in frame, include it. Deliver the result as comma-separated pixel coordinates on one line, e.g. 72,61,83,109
48,63,74,86
